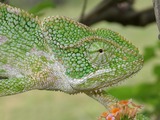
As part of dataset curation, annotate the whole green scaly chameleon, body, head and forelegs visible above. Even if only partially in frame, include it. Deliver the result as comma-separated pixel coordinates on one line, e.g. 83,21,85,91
0,3,143,107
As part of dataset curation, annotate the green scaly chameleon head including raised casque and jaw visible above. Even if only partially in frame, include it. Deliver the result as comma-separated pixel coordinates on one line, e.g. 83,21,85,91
43,17,143,91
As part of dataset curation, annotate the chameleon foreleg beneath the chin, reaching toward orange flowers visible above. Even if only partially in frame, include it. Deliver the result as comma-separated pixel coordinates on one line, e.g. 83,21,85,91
86,90,118,110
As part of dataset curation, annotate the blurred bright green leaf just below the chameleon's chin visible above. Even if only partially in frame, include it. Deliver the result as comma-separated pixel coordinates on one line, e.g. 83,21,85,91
108,82,160,106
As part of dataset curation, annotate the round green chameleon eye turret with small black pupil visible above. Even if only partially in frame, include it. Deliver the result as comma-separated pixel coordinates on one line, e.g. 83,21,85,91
87,41,114,67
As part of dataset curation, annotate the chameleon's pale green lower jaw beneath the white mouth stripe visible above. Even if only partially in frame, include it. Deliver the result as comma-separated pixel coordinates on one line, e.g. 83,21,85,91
72,58,142,93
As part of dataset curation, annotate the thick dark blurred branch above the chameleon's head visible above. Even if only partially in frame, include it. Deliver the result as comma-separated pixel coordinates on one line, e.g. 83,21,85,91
80,0,155,26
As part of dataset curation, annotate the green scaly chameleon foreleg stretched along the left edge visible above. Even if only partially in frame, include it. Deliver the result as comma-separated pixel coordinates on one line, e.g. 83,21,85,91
0,77,34,96
